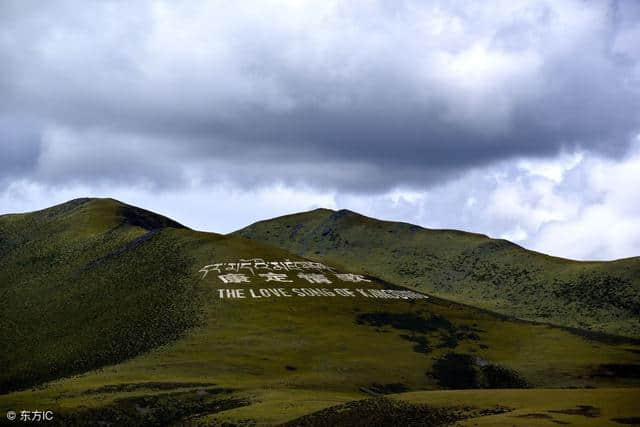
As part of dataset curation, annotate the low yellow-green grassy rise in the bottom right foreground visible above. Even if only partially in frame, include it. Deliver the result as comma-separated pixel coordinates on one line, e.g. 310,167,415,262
278,388,640,427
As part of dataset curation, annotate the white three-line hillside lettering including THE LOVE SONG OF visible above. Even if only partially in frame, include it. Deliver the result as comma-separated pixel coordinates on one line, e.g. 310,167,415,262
199,258,428,299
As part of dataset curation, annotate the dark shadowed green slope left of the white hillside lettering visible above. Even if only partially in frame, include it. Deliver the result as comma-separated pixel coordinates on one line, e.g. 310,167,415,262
0,199,197,392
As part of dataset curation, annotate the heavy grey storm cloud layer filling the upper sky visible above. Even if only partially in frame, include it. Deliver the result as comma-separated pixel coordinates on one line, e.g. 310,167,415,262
0,1,640,189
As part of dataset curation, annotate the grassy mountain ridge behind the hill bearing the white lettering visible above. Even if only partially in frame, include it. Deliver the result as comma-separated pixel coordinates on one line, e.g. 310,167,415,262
234,209,640,337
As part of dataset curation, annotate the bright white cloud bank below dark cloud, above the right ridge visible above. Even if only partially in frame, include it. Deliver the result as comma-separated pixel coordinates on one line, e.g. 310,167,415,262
324,138,640,260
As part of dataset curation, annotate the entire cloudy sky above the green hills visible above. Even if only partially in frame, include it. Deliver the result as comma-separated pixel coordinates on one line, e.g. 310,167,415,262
0,0,640,259
